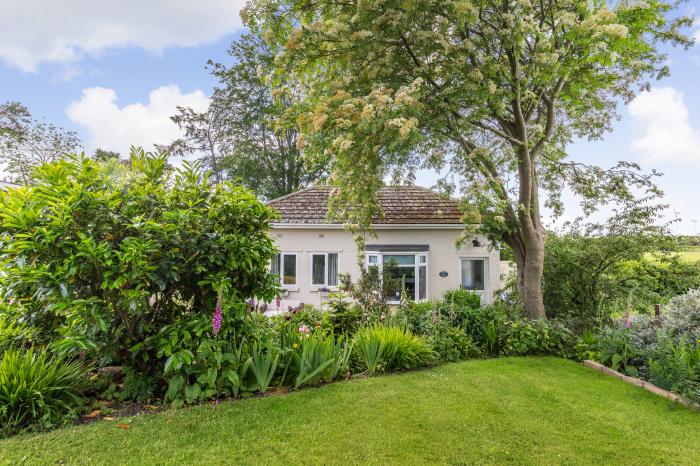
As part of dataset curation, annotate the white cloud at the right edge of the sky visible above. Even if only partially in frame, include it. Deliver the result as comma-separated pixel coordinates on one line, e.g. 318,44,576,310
629,87,700,165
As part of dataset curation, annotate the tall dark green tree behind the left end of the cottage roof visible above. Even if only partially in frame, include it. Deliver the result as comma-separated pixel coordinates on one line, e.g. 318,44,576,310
172,35,323,199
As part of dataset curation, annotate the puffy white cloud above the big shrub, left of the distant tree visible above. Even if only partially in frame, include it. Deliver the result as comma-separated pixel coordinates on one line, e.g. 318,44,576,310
66,85,209,155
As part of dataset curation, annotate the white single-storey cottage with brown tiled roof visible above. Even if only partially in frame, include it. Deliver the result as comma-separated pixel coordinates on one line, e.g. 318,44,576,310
269,186,500,309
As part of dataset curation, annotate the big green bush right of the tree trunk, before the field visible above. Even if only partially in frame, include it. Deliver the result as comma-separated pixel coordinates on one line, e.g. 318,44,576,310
543,203,700,326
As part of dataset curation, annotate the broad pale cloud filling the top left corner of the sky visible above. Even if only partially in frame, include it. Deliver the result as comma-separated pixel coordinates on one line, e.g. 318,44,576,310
0,0,244,71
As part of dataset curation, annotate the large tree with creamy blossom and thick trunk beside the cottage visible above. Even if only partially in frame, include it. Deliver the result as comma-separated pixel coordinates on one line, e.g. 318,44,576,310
244,0,692,317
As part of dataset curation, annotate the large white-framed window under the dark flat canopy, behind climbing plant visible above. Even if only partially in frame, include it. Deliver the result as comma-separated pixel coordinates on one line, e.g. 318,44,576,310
367,253,428,302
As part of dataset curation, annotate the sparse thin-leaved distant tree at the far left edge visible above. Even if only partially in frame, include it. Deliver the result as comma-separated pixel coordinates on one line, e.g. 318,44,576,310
0,102,80,184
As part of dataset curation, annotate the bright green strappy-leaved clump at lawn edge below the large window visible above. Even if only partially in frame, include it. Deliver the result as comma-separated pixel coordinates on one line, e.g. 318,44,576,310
353,324,434,374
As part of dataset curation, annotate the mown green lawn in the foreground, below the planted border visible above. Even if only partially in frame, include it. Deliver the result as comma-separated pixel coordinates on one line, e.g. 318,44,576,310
0,357,700,465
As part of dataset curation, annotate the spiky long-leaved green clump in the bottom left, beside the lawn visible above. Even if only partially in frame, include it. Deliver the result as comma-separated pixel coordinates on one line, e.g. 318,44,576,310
0,348,86,434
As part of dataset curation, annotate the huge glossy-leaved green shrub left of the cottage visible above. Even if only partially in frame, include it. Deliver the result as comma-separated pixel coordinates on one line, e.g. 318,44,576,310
0,151,275,372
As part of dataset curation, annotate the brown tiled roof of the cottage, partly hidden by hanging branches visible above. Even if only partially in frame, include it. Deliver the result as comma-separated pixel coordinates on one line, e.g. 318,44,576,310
269,186,462,225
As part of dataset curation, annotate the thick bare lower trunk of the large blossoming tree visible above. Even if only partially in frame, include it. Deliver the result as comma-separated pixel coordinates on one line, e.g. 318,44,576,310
513,232,547,319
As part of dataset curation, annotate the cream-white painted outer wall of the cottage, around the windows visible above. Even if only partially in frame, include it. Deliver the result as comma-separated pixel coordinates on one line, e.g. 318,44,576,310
271,225,500,311
